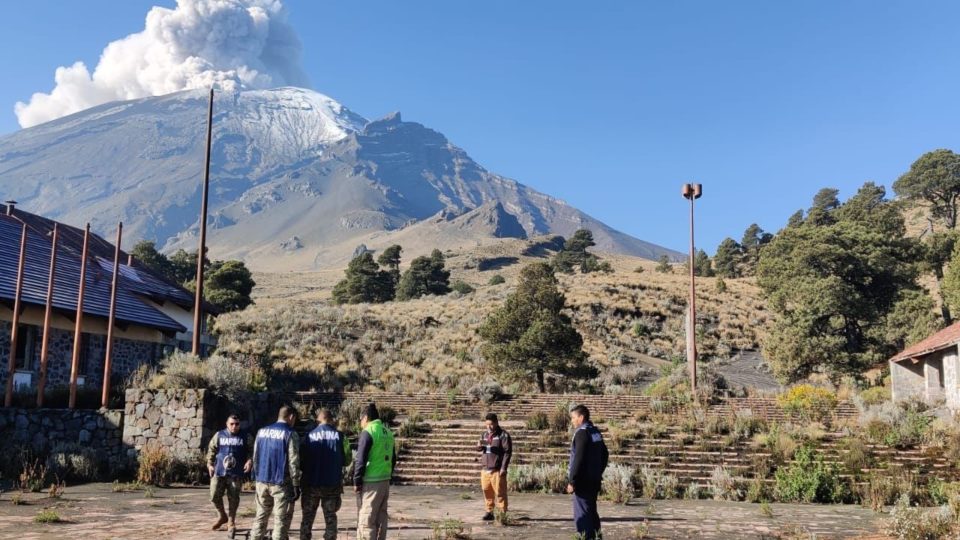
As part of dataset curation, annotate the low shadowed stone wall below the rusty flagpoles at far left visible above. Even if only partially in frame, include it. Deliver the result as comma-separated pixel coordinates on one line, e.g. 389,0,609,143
0,407,126,469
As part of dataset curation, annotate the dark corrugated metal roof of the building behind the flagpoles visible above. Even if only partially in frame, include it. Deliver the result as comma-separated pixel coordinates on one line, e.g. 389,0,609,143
0,215,189,332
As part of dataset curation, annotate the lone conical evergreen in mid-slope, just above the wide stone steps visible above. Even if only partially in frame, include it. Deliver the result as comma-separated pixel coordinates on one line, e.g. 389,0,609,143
480,263,596,392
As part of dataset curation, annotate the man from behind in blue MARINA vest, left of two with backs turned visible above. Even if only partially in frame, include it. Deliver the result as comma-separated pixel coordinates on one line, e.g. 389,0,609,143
250,405,300,540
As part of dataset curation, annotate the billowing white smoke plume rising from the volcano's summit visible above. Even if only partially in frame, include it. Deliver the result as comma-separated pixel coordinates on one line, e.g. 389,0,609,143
14,0,308,128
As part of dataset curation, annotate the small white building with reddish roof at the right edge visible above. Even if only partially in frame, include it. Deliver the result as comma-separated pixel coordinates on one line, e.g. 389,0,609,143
890,322,960,411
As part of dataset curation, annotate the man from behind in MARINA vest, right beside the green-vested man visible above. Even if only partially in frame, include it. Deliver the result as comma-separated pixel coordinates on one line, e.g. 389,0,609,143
300,409,353,540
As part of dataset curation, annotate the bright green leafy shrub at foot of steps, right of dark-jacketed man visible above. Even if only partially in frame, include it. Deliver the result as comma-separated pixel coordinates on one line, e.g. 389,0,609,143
774,446,846,503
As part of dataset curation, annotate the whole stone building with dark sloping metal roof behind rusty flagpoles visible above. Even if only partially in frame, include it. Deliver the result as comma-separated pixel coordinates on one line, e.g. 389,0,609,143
0,203,208,387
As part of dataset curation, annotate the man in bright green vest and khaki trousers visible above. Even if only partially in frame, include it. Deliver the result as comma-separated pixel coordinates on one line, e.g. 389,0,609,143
353,403,397,540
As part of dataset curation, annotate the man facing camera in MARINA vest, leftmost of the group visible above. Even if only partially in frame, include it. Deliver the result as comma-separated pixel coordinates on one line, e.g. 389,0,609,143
207,414,253,531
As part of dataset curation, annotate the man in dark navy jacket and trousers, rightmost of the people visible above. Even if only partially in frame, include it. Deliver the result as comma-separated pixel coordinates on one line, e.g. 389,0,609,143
567,405,609,540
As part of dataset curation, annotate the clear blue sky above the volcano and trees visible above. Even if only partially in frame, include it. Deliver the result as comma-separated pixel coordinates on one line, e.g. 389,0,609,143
0,0,960,252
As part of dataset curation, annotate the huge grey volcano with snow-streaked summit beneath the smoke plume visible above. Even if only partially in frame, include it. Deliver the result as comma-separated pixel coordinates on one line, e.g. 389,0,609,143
0,88,682,270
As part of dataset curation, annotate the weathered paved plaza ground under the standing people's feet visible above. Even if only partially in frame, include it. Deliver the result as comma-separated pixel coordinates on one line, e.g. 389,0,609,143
0,484,884,540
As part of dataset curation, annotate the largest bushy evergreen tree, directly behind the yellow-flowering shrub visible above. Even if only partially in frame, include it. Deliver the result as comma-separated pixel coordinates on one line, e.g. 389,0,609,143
758,183,918,382
